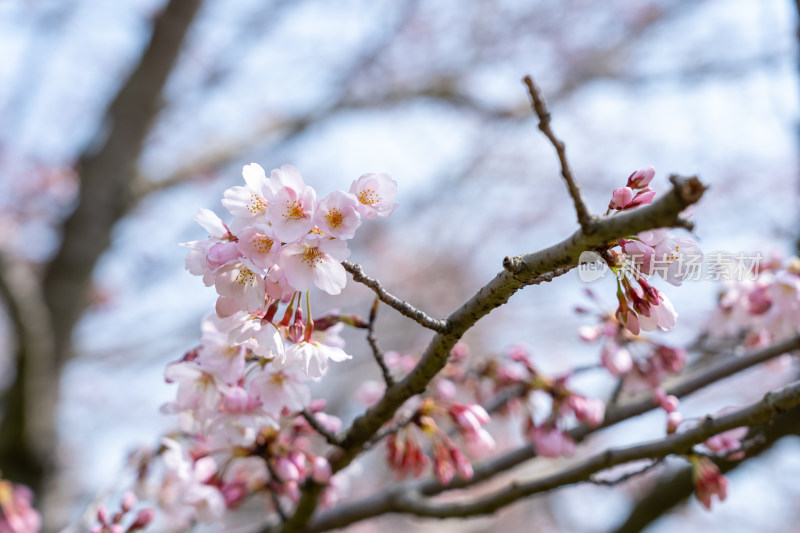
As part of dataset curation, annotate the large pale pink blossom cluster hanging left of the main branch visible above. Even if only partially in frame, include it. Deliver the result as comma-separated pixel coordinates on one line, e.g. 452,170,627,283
142,163,397,529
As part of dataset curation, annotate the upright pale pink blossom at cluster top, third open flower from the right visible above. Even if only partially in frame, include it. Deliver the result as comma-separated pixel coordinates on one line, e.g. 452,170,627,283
266,165,317,243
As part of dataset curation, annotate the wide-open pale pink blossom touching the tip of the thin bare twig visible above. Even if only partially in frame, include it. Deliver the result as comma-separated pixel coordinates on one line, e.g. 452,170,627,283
278,234,350,295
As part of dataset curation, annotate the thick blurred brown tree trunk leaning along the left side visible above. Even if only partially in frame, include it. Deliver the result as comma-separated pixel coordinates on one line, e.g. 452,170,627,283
0,0,201,531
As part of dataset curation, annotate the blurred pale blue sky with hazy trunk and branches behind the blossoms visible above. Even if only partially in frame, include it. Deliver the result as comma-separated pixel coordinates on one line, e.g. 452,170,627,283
0,0,800,532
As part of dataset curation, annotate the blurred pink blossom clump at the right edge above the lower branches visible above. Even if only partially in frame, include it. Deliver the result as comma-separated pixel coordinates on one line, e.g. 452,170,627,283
707,258,800,348
